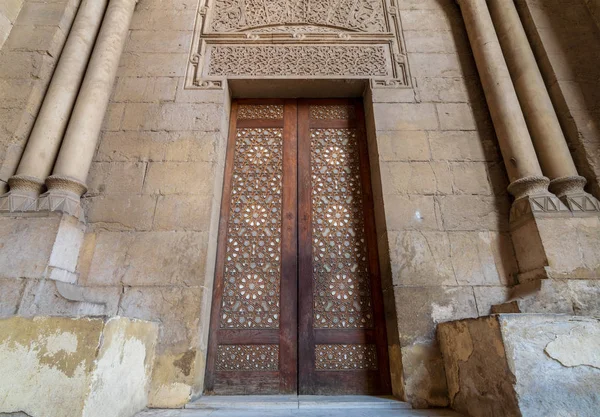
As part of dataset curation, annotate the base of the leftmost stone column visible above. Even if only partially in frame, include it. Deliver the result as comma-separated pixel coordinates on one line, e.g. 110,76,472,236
0,175,44,213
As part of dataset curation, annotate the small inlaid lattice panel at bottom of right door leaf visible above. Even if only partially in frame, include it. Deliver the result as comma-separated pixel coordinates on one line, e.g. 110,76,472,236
315,345,377,371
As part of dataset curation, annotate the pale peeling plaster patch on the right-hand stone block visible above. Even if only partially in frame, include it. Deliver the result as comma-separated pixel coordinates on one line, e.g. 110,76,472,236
544,325,600,369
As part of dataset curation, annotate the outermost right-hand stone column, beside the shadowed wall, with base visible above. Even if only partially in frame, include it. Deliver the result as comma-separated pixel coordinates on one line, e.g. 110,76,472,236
487,0,597,210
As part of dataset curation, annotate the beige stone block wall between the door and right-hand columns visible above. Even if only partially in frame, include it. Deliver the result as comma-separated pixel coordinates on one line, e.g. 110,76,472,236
373,0,516,406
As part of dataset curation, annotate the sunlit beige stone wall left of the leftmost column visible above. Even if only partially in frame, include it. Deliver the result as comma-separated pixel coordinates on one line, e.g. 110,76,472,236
0,0,79,193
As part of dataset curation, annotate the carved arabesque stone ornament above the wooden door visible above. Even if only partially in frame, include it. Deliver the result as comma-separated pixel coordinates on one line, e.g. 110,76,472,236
186,0,411,89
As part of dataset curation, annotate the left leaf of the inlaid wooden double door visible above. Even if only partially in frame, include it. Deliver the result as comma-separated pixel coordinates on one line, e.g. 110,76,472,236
205,100,297,394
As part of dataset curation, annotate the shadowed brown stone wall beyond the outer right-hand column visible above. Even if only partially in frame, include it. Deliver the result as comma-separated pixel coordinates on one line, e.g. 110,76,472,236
517,0,600,198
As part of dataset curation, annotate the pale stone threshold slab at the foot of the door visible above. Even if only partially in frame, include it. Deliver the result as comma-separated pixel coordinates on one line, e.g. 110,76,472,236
185,395,411,410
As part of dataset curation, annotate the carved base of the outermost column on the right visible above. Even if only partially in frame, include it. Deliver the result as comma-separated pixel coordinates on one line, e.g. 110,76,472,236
549,175,600,216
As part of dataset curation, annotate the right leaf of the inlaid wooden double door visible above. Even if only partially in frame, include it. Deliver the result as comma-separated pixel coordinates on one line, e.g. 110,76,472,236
298,100,391,395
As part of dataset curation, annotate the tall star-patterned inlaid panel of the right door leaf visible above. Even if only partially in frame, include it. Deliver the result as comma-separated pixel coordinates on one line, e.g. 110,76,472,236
310,129,373,329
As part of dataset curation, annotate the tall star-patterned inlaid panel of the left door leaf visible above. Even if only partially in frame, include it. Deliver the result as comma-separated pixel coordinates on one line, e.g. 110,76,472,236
221,128,283,329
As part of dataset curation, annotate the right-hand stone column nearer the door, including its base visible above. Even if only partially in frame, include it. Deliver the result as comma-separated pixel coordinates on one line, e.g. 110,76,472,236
458,0,550,200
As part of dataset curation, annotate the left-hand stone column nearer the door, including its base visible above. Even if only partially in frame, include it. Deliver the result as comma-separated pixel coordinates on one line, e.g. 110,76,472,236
38,0,137,217
